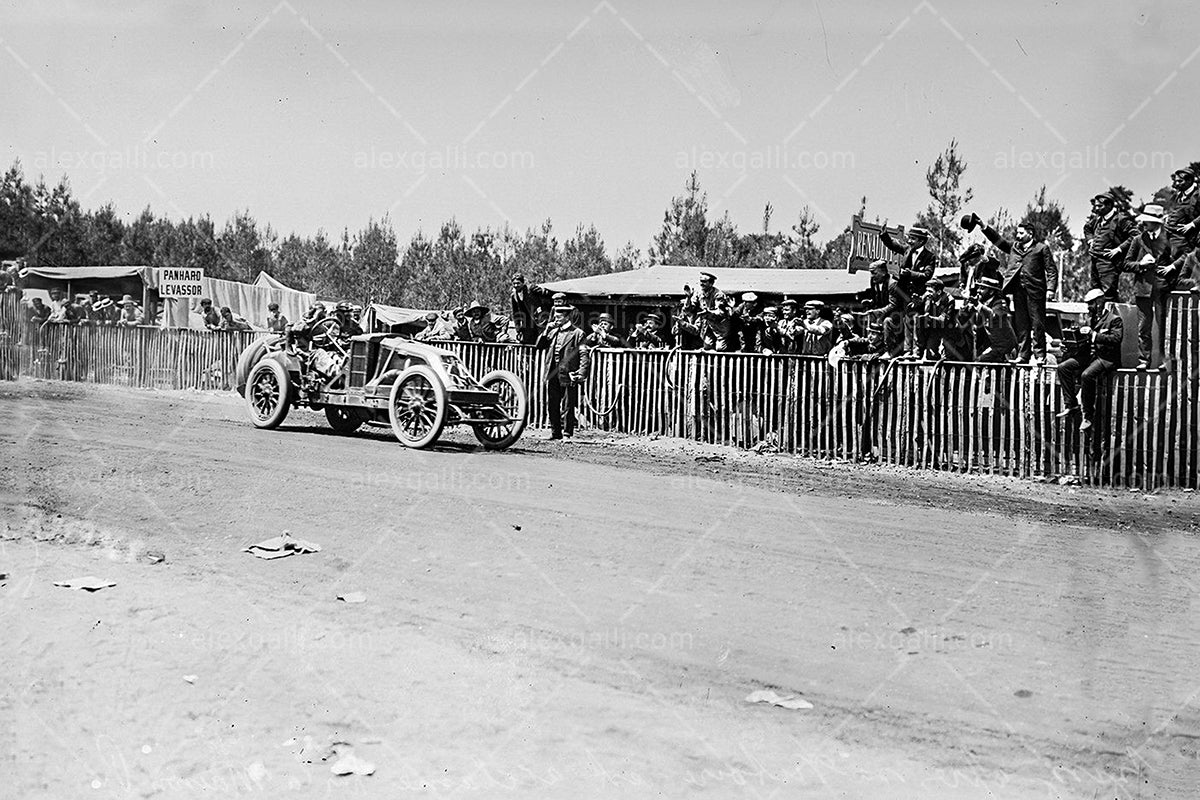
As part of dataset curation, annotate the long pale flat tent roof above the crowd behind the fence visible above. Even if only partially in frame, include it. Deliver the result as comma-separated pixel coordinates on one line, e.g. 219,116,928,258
542,264,871,297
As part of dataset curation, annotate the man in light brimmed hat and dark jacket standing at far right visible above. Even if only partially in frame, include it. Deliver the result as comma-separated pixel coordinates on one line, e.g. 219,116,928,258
1126,204,1187,369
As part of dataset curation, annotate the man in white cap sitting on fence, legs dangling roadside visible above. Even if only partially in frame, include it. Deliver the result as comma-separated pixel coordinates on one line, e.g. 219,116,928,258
1058,289,1124,431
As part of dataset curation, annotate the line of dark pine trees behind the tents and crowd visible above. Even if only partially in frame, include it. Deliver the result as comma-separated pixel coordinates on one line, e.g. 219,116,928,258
0,140,1166,308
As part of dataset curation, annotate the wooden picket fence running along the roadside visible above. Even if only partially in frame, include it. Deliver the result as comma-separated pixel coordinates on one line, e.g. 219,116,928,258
0,294,1200,489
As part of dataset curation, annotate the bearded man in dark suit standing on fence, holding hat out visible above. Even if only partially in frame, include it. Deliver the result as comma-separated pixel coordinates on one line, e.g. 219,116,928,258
971,215,1058,363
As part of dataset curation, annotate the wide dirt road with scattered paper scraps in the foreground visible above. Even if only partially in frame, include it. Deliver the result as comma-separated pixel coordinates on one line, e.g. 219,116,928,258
0,383,1200,799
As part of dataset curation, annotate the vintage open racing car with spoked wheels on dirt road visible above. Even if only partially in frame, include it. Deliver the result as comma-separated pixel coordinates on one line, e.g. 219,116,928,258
236,333,529,450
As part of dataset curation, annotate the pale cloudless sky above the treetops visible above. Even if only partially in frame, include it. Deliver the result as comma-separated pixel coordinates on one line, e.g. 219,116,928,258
0,0,1200,251
